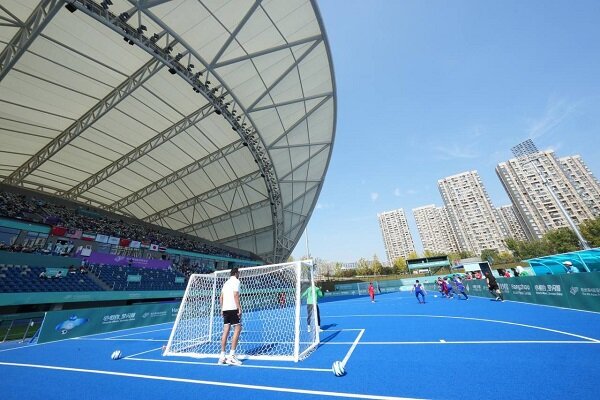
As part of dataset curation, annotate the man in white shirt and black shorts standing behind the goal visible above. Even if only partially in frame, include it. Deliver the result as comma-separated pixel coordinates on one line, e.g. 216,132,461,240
218,268,242,365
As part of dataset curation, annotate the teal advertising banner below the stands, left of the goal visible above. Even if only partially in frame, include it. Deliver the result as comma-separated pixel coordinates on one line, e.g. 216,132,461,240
38,303,179,343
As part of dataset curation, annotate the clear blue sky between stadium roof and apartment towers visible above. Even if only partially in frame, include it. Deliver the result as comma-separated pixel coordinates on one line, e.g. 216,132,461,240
293,0,600,262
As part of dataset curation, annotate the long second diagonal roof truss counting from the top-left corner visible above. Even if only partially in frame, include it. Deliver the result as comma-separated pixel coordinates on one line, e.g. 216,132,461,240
4,59,163,185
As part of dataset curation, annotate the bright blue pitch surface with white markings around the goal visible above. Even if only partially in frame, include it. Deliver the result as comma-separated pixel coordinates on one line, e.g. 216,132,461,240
0,293,600,400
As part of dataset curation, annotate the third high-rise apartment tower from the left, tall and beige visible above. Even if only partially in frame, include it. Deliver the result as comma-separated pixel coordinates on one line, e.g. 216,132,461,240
438,171,507,255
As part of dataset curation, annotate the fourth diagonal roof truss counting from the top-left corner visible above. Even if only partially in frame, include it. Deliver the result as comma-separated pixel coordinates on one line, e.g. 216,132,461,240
103,140,245,211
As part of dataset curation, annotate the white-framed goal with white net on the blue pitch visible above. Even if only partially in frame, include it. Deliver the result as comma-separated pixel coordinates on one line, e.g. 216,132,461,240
163,260,319,361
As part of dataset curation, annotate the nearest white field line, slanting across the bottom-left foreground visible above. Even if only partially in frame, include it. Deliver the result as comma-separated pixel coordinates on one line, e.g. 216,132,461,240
0,361,422,400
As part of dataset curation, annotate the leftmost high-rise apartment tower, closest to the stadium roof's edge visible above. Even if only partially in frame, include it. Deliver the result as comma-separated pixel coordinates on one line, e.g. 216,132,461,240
377,208,415,264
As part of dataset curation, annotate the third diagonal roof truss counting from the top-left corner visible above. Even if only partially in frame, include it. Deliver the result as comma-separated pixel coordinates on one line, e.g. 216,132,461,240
65,103,214,198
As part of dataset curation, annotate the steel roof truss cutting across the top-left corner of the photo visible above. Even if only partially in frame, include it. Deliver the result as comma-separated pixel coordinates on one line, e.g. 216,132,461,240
0,0,64,82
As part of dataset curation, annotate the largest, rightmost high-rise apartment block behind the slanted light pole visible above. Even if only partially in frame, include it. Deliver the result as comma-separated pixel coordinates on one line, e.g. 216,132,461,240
496,150,594,239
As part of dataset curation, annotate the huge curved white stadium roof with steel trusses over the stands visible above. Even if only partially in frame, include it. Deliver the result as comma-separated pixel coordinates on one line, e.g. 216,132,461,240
0,0,336,262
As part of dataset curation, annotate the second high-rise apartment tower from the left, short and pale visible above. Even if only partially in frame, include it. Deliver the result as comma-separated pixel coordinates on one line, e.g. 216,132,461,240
412,204,458,254
